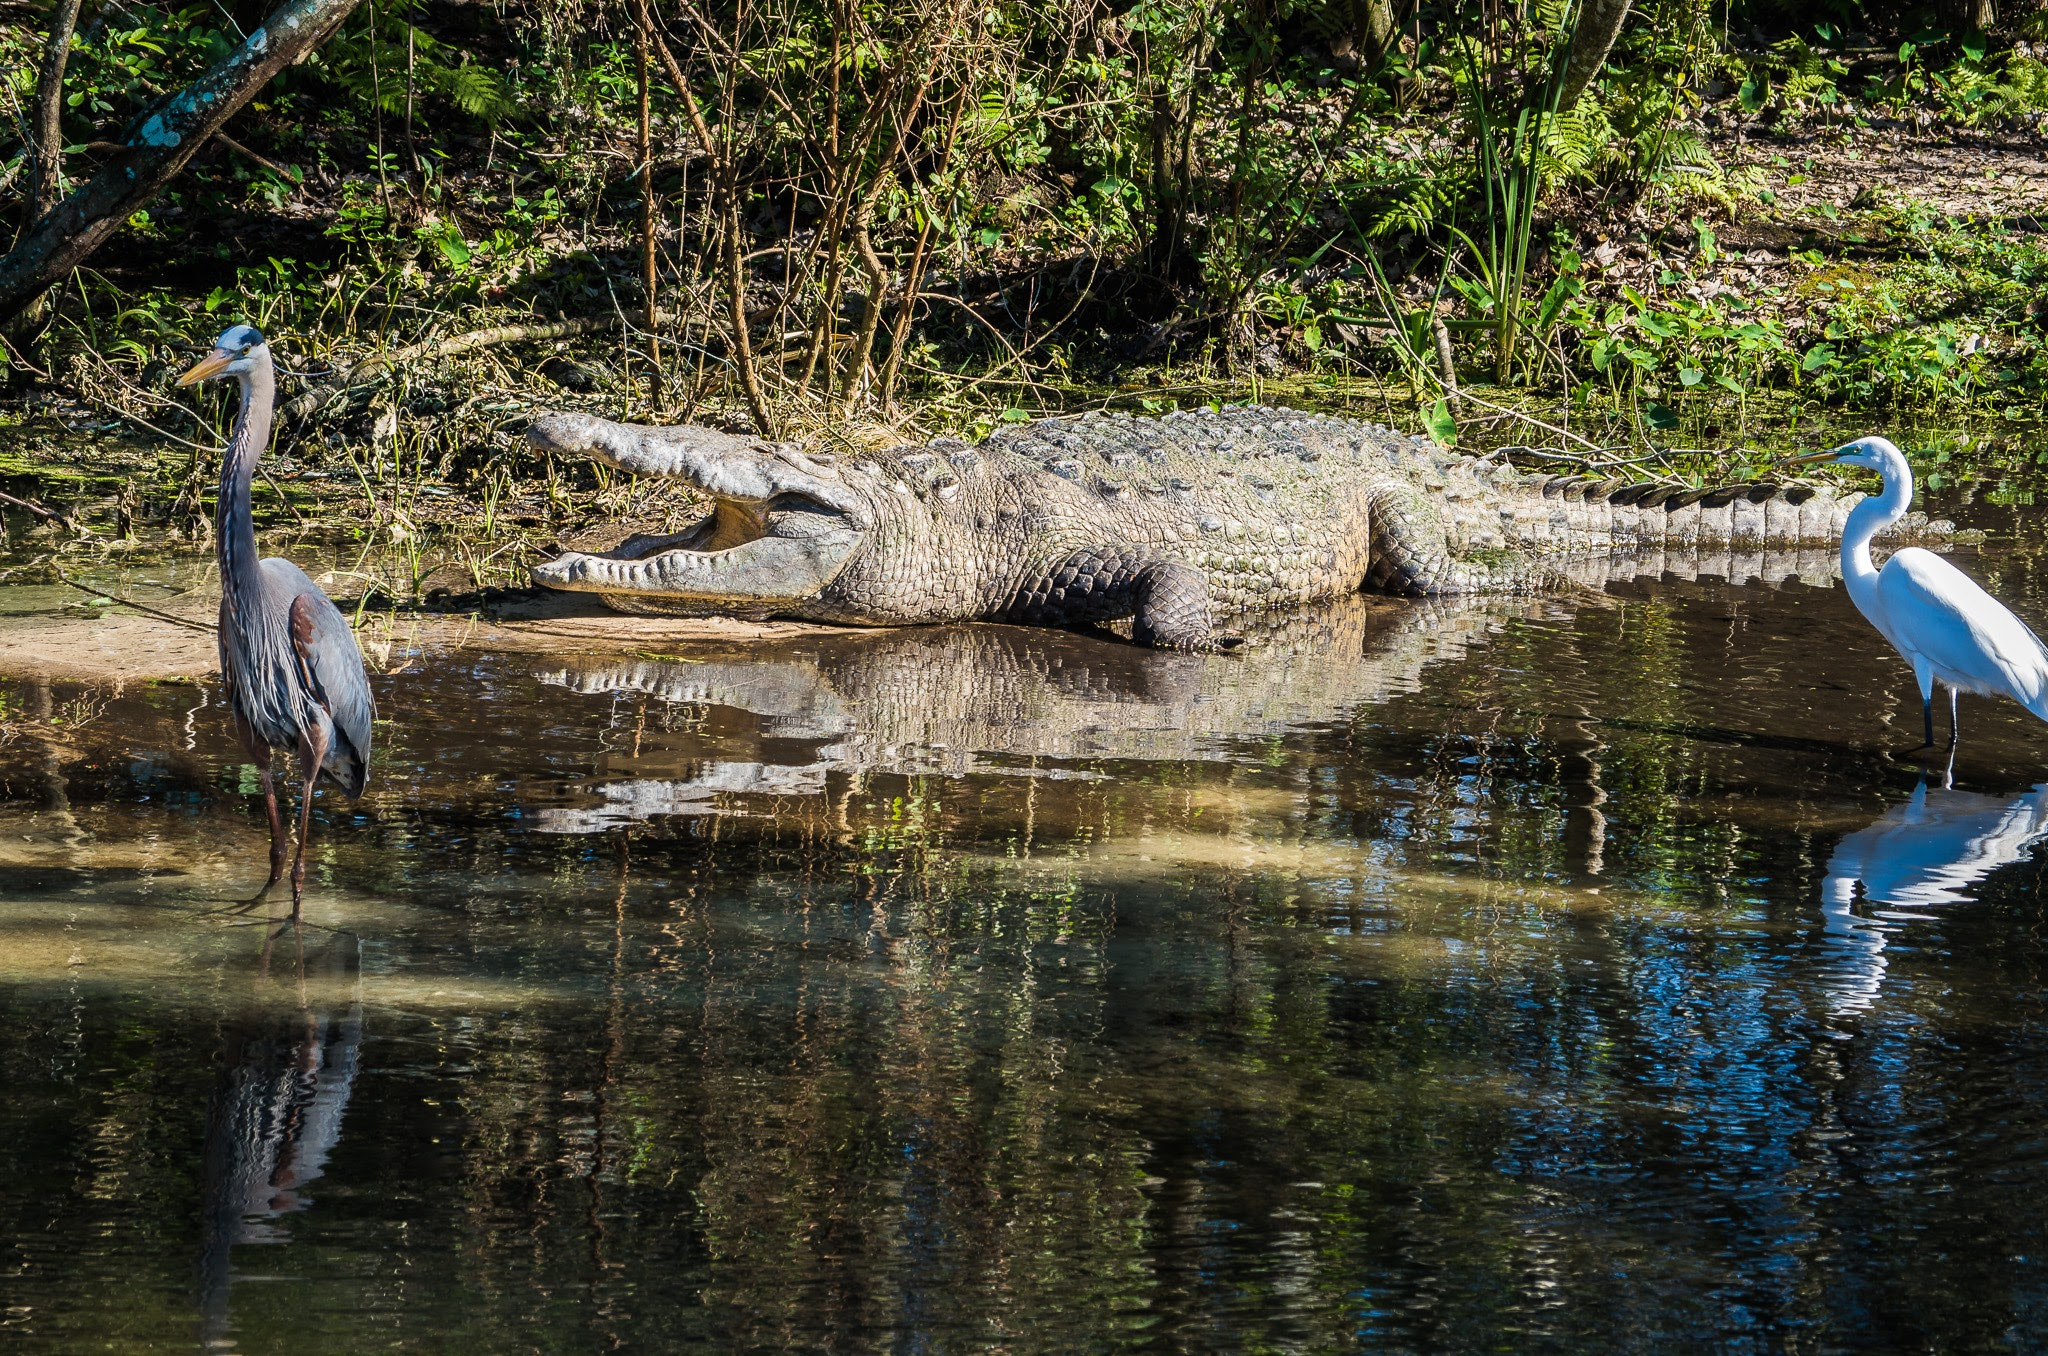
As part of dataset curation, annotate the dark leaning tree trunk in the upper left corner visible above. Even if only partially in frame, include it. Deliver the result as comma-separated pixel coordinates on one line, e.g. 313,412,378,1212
0,0,360,320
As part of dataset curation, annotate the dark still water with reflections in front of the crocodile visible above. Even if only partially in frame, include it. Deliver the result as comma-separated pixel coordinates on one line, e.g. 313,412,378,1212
0,485,2048,1352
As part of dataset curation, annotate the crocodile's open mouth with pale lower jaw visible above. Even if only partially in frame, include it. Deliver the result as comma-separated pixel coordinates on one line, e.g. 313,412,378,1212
532,494,860,615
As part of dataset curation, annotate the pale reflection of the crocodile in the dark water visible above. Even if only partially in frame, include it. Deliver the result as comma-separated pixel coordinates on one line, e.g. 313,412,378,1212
539,598,1561,834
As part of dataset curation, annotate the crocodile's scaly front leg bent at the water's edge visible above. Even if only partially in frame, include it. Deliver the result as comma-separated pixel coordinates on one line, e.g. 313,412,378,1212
999,547,1243,649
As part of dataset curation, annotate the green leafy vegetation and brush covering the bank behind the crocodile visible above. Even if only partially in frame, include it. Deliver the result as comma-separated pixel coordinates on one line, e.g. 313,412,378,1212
0,0,2048,577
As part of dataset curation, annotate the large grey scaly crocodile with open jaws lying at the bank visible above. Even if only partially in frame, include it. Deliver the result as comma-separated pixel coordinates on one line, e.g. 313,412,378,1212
526,406,1954,649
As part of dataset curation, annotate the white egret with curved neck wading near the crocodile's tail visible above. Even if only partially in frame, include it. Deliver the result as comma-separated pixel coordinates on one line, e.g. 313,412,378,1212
1794,438,2048,748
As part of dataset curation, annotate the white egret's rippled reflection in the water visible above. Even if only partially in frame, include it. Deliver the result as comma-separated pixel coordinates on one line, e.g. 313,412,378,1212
1821,780,2048,1014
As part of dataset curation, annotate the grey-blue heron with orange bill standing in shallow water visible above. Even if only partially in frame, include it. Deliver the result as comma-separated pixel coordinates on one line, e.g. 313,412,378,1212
178,326,375,918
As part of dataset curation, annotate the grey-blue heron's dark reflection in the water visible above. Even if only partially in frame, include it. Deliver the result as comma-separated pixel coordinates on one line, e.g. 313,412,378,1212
199,926,362,1352
